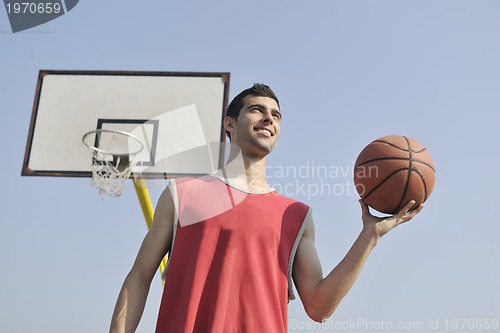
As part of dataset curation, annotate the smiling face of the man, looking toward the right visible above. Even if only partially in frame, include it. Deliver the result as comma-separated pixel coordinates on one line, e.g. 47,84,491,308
230,95,281,156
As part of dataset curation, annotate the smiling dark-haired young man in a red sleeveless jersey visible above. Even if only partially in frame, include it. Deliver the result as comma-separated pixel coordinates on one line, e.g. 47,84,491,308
110,84,423,333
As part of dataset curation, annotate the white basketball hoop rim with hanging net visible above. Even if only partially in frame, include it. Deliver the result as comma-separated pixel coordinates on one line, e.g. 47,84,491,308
82,129,144,197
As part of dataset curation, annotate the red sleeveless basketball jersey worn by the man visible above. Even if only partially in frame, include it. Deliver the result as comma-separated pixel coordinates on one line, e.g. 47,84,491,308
156,176,309,333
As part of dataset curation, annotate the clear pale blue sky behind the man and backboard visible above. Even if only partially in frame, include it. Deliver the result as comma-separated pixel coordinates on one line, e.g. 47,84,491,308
0,0,500,333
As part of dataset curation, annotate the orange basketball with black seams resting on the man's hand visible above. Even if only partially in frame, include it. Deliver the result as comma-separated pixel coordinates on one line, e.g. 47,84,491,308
354,135,436,214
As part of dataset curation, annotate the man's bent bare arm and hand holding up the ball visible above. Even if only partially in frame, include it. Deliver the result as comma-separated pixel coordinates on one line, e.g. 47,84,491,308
293,200,423,322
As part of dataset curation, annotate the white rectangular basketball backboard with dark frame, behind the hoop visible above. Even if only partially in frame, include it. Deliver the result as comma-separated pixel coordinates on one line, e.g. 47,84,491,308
22,70,229,178
